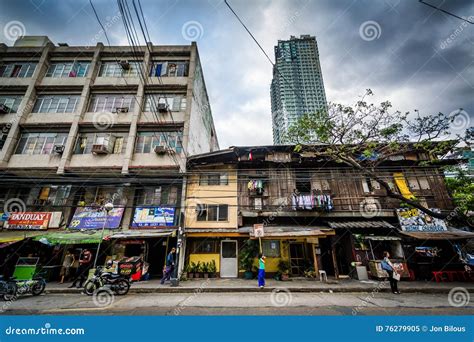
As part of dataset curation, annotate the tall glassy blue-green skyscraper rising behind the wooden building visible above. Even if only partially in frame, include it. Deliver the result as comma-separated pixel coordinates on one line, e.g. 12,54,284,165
270,35,327,145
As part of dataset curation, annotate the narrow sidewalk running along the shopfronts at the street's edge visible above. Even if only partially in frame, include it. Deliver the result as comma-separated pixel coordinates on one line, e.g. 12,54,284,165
46,278,474,293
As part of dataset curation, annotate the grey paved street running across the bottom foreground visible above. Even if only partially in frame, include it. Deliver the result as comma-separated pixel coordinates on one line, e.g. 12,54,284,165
0,291,474,316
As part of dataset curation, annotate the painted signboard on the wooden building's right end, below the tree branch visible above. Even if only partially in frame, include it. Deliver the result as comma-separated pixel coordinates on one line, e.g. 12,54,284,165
397,208,448,232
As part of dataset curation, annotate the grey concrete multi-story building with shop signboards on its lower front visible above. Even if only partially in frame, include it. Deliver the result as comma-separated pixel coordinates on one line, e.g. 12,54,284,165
0,37,218,280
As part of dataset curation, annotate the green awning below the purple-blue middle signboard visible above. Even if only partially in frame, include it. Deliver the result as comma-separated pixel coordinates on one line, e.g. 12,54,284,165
35,229,113,245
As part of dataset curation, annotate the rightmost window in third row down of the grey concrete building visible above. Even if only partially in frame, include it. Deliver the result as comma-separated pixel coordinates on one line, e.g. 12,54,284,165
135,131,183,153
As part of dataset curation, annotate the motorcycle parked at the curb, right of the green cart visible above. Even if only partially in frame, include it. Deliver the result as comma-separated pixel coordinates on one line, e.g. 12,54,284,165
84,266,130,296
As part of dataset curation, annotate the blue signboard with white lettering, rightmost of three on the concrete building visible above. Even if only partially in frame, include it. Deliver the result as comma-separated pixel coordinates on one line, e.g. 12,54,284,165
131,207,175,228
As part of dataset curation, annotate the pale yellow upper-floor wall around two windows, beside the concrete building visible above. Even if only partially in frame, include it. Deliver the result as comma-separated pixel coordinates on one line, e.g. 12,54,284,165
185,165,237,228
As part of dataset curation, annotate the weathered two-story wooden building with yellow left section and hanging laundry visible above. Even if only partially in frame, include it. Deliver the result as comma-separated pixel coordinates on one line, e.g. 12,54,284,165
185,145,474,279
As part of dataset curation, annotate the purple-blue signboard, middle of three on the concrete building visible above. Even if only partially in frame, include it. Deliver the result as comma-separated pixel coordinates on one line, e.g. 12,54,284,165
69,207,124,229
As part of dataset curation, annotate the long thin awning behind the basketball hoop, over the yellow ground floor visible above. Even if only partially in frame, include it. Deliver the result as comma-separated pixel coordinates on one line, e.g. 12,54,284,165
239,226,336,238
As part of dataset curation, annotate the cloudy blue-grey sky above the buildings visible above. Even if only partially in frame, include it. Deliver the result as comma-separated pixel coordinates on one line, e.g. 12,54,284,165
0,0,474,148
